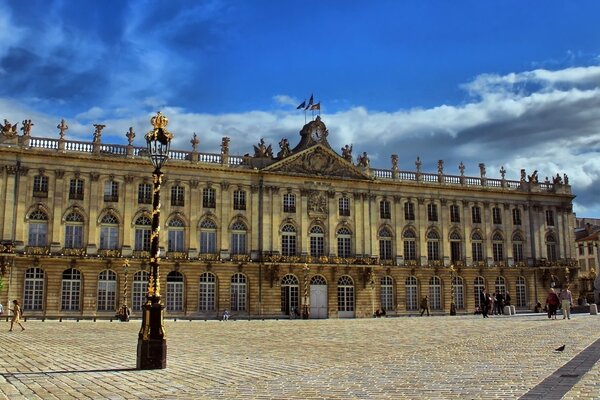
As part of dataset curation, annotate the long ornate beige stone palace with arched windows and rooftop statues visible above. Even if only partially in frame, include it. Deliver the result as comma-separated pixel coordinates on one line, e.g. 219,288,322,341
0,117,577,318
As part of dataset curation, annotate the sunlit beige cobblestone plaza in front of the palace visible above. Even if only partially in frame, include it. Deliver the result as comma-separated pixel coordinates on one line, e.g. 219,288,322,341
0,314,600,400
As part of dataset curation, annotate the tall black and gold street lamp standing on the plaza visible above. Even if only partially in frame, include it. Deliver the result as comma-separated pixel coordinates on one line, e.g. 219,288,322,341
137,111,173,369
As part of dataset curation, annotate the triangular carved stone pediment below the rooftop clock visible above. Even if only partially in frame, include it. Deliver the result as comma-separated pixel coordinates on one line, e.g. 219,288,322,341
264,145,370,179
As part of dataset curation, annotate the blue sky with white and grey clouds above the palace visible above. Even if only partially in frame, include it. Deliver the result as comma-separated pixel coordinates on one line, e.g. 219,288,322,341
0,0,600,217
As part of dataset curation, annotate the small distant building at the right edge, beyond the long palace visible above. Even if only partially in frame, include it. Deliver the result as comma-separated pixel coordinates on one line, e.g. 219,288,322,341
575,218,600,302
